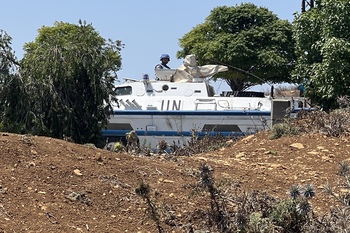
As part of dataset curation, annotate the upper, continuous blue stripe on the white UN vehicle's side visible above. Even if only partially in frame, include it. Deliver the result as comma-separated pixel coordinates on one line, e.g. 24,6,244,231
113,110,271,116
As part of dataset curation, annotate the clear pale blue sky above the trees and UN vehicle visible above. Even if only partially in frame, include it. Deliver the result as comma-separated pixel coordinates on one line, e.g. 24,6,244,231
0,0,302,90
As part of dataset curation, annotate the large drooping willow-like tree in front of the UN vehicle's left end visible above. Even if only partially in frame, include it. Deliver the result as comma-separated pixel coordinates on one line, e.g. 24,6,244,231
6,21,123,143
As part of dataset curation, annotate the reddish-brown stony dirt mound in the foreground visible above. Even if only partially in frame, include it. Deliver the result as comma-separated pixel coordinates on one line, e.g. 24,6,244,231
0,133,350,232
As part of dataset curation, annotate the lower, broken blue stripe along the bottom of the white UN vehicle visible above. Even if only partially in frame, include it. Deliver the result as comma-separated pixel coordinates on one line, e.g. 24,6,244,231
102,130,251,137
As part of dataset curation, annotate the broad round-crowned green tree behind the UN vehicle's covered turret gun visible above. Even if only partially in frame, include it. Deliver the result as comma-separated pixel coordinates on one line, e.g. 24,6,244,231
177,3,295,91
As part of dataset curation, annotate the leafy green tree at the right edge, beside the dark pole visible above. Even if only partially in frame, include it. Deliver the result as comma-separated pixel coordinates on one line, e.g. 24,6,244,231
293,0,350,110
